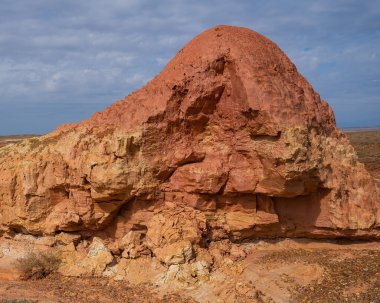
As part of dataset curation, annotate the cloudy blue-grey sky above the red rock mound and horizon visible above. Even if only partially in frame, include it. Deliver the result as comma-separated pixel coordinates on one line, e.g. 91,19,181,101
0,0,380,135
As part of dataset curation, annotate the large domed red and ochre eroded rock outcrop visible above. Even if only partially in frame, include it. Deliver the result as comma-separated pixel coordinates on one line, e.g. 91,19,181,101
0,26,380,247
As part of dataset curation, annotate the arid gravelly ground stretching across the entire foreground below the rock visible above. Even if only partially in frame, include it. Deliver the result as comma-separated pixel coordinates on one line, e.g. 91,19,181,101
0,239,380,303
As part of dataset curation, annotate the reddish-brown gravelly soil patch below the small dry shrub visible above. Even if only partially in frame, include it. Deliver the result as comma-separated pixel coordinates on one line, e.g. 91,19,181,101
0,276,195,303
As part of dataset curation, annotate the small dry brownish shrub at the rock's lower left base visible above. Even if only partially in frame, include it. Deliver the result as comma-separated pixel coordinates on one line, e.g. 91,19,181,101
16,252,60,279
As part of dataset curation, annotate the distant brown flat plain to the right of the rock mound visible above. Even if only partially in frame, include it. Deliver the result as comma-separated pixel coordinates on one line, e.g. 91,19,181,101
346,129,380,186
